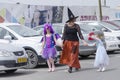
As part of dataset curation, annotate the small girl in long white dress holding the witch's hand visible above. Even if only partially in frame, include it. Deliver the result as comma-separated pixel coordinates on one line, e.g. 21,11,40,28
88,33,109,72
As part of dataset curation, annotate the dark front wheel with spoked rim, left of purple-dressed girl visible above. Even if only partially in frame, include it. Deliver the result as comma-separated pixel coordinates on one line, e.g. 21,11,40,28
25,49,38,68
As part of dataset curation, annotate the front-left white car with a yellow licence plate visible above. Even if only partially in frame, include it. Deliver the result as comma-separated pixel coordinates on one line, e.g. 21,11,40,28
0,37,28,73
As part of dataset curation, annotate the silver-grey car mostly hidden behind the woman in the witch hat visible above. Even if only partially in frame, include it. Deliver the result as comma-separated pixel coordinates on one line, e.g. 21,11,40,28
33,23,104,57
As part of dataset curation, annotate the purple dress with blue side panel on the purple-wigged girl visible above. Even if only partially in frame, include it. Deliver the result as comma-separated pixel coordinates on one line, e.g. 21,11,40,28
42,35,57,59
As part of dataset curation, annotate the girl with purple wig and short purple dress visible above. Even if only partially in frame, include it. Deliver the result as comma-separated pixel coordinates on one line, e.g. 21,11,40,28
41,23,57,72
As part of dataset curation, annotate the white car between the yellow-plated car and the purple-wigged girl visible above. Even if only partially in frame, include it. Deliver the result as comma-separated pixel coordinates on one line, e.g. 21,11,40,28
0,23,53,68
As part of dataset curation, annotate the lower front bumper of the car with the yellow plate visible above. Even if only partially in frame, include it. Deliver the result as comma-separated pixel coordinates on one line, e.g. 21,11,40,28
0,60,27,71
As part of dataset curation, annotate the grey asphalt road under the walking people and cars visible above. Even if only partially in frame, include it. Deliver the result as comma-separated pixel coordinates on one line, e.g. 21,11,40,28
0,52,120,80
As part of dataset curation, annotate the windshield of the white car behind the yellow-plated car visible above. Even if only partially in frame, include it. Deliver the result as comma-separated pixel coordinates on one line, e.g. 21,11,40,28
7,25,40,37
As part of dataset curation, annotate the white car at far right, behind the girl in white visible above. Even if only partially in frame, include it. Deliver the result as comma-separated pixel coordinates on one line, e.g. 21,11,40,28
76,21,120,52
